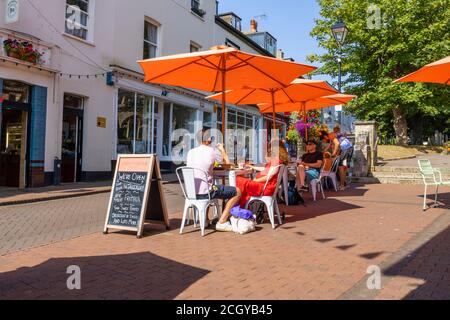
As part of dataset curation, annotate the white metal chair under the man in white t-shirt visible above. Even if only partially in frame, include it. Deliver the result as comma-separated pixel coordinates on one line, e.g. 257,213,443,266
176,167,219,237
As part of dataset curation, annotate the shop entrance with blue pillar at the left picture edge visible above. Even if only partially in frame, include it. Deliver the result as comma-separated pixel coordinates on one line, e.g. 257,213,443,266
0,79,46,188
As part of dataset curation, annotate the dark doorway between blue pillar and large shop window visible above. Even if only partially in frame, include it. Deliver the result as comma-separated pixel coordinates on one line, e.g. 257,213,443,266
61,95,84,183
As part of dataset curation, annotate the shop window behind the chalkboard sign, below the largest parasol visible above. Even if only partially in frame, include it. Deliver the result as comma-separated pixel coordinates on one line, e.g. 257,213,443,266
116,84,208,169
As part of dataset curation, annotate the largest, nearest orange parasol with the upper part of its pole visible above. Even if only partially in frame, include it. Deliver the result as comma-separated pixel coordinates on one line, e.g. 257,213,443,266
138,46,316,133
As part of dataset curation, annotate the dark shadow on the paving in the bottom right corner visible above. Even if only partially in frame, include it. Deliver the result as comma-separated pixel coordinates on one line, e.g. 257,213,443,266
384,227,450,300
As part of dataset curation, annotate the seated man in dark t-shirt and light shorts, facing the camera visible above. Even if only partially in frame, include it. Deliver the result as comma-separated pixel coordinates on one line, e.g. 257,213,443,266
297,140,323,191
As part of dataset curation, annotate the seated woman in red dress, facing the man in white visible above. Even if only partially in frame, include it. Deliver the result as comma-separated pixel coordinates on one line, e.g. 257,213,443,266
236,141,289,208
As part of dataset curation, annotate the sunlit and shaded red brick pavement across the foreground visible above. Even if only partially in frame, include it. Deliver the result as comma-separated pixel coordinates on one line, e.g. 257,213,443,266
0,185,450,299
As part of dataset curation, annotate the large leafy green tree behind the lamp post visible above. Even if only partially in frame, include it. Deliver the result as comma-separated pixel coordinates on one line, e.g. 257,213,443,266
309,0,450,144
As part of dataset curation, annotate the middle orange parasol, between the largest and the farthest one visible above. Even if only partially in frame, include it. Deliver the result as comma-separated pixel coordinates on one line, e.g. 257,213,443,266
206,79,337,129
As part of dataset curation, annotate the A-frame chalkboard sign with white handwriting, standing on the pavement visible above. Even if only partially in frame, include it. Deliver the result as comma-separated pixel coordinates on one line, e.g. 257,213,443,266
103,155,169,239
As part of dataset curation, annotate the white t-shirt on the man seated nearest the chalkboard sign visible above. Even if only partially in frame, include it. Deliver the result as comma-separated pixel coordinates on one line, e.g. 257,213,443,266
186,145,216,195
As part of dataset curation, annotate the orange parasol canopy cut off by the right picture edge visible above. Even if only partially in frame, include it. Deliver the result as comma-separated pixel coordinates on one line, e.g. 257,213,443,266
395,56,450,85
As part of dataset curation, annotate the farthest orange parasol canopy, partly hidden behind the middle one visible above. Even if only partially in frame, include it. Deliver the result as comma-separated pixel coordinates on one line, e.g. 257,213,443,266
258,93,356,113
